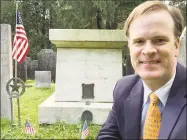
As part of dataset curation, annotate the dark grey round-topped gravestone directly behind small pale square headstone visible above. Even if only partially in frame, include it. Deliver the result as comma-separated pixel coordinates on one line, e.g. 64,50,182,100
38,49,56,82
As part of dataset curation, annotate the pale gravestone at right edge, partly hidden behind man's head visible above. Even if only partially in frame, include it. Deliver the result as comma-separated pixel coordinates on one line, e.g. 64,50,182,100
178,27,186,67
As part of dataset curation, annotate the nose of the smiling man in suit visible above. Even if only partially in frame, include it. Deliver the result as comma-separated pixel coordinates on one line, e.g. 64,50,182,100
142,42,157,55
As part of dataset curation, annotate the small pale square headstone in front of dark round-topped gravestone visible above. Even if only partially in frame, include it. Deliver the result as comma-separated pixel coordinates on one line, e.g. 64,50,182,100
35,71,51,88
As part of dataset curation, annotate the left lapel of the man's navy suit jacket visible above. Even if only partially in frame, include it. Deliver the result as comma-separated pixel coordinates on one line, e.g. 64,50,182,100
124,80,143,139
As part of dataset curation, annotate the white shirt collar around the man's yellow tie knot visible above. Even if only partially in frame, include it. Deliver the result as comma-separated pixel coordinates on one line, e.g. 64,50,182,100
142,72,176,106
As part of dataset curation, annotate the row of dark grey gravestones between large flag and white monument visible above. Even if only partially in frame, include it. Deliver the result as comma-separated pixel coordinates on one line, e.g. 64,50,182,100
17,49,56,82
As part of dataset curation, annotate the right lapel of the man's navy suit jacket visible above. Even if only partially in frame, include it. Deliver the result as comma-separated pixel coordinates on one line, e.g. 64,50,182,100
159,63,186,139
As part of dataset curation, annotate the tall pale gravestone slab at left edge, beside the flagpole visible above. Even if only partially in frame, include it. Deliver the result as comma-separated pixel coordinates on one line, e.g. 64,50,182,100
1,24,13,120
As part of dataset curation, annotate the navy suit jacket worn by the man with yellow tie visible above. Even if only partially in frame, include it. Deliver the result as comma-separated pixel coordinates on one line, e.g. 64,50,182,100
97,63,187,140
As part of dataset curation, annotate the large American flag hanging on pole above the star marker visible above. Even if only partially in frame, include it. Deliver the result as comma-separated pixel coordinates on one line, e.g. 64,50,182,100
12,11,29,63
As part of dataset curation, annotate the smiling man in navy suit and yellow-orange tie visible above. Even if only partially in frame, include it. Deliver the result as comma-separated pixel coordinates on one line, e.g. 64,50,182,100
97,1,187,140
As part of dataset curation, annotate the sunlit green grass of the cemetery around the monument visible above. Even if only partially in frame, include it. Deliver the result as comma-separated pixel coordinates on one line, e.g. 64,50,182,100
1,80,101,139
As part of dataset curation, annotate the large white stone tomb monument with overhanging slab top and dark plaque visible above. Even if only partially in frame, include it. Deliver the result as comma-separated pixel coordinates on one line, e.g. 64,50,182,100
38,29,127,124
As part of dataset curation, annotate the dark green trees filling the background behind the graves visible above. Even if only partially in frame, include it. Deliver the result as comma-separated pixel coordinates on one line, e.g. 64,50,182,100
1,0,186,59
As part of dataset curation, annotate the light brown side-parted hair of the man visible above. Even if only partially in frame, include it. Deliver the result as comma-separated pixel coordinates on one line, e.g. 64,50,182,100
124,1,184,38
